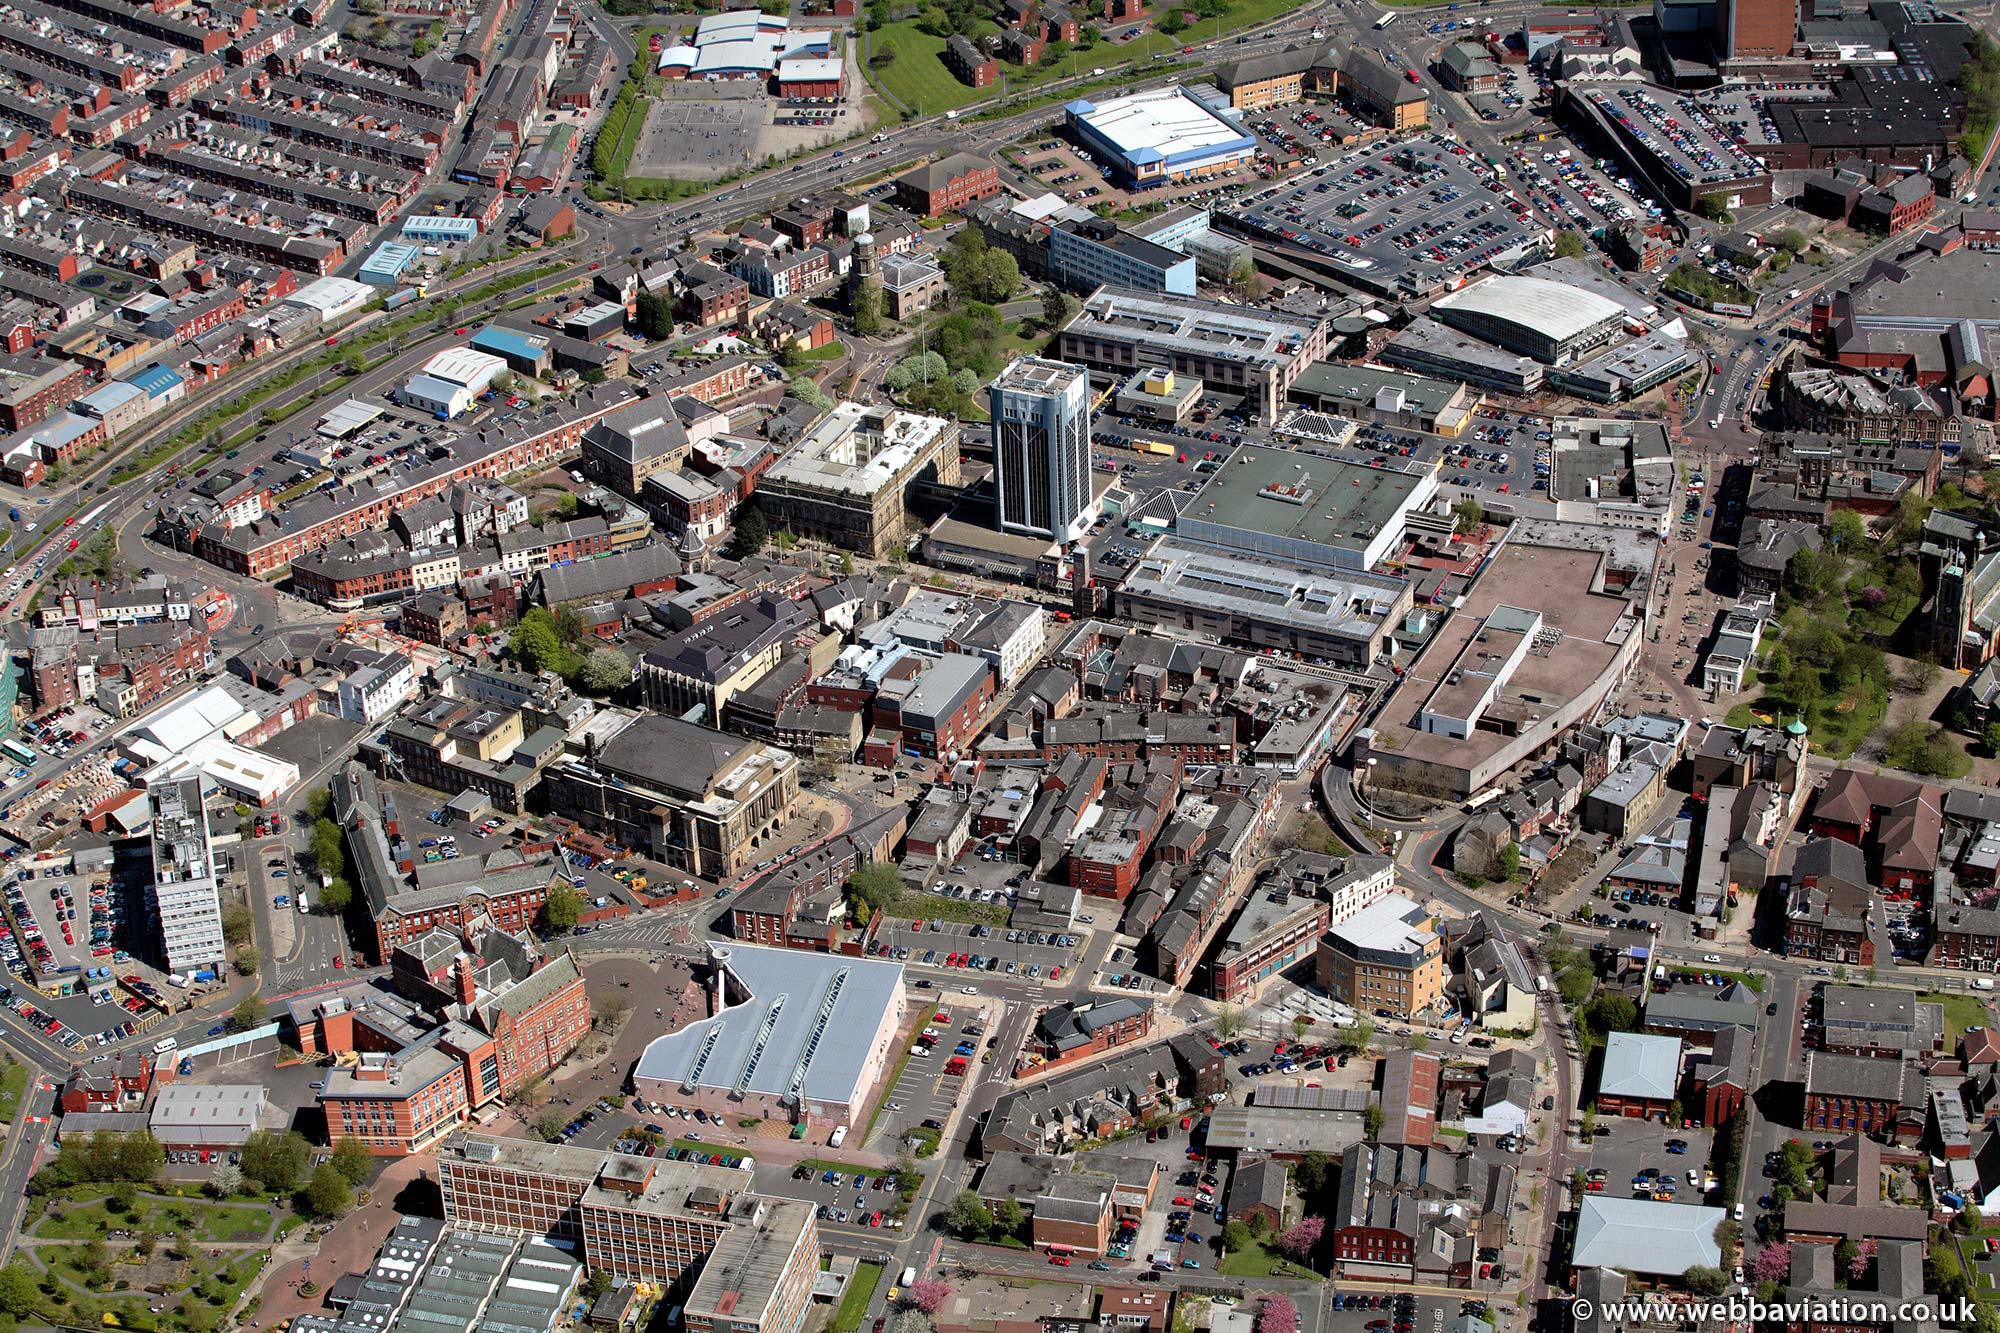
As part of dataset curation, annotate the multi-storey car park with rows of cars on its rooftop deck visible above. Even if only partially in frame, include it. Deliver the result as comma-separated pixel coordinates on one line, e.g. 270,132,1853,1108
1562,86,1772,208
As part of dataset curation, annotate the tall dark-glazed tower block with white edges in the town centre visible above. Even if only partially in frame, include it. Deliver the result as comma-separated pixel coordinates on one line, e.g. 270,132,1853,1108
990,356,1090,540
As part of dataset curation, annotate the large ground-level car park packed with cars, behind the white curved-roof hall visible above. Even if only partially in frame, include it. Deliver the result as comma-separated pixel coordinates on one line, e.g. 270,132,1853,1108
1216,136,1548,298
